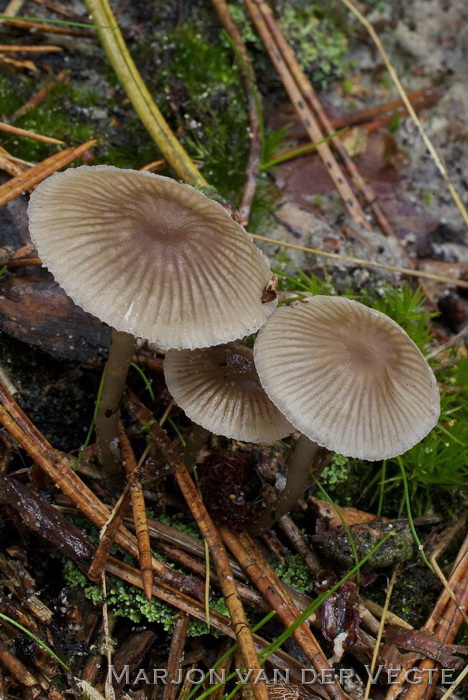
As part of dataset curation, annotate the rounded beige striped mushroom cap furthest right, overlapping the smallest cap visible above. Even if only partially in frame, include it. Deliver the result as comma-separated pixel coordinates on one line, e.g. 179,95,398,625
254,296,440,460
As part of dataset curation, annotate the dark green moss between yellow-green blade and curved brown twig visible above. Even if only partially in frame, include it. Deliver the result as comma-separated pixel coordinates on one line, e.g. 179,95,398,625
154,22,248,203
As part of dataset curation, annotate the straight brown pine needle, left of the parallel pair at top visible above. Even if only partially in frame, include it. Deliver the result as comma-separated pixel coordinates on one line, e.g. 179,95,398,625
245,0,371,231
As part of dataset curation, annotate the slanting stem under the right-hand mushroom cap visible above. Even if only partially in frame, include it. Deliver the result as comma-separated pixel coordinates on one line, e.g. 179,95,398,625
250,435,333,535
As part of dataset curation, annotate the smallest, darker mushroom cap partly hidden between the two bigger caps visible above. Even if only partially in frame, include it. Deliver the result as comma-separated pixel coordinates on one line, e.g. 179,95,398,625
164,345,294,442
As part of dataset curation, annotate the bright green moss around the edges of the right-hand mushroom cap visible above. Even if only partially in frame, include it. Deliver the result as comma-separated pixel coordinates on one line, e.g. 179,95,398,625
281,272,468,517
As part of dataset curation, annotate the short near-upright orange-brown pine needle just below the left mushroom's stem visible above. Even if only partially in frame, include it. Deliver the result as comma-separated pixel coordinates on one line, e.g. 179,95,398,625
118,422,153,600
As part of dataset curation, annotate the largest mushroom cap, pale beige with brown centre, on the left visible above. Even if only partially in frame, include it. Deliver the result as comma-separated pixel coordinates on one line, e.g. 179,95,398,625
29,165,275,348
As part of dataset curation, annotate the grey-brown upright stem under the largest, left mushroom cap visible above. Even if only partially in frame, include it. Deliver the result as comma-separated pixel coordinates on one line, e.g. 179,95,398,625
96,328,135,476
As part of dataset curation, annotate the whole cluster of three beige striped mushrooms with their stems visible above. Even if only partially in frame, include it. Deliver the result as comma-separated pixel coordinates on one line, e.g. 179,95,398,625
29,166,440,532
